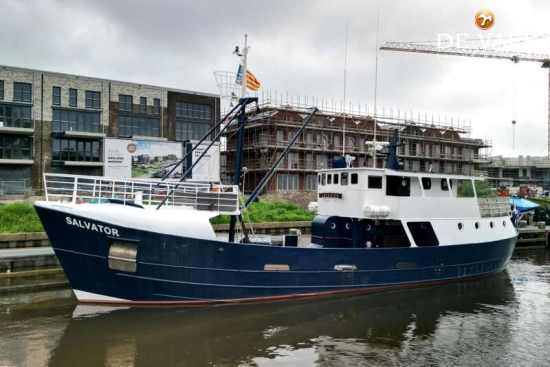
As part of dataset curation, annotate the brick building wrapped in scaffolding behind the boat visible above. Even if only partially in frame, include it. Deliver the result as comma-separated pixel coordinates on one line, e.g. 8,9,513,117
221,102,491,193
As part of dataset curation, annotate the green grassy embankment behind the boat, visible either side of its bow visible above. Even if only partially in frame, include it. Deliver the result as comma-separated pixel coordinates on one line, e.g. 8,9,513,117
0,200,315,233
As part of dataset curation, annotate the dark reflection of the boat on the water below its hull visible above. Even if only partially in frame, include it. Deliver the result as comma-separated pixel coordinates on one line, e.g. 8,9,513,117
49,272,519,366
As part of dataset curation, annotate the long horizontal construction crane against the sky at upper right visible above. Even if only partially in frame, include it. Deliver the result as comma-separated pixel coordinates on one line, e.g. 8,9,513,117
380,42,550,157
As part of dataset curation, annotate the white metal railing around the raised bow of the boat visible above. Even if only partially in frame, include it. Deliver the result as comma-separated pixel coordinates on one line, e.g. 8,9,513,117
44,173,240,214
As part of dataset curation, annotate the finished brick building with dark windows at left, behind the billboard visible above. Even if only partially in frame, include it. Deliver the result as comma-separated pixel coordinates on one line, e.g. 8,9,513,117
0,66,220,194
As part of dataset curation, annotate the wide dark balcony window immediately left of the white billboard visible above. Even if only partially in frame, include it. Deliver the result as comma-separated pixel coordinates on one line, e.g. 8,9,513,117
52,139,99,162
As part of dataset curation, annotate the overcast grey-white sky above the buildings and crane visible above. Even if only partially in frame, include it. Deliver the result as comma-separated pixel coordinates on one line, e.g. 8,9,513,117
0,0,550,157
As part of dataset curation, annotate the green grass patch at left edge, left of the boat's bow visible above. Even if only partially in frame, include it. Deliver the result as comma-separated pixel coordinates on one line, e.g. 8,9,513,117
0,204,44,233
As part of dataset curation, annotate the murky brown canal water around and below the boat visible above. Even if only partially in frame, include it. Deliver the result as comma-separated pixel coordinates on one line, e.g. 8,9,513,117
0,250,550,367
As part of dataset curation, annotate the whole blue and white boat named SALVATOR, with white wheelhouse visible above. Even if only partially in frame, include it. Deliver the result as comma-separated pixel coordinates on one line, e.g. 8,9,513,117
34,91,517,305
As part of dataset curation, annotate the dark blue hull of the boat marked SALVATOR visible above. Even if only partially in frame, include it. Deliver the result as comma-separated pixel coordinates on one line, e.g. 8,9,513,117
36,207,516,305
